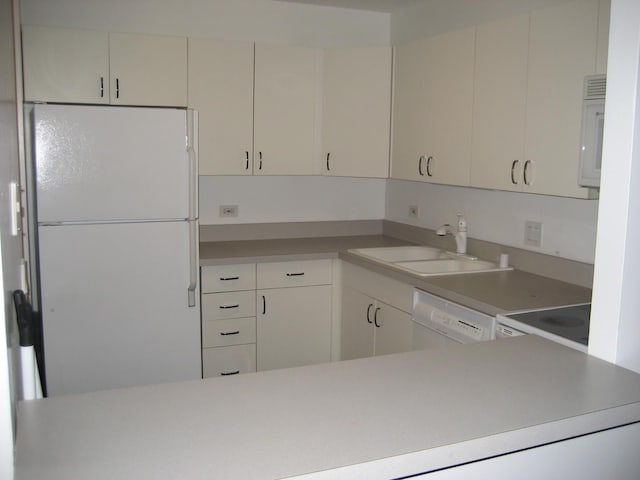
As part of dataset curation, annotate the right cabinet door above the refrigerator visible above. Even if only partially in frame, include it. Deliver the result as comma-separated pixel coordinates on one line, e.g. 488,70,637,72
109,33,187,107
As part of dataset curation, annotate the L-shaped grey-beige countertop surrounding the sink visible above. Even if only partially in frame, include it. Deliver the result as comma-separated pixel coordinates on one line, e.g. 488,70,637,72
200,235,591,315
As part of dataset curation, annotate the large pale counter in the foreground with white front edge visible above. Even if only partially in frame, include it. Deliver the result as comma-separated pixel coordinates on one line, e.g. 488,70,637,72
15,335,640,480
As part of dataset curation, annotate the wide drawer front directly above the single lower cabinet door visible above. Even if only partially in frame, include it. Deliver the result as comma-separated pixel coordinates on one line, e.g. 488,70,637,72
257,260,332,288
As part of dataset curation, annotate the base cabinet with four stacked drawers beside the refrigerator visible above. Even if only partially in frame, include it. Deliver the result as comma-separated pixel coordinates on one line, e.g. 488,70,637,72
201,260,333,378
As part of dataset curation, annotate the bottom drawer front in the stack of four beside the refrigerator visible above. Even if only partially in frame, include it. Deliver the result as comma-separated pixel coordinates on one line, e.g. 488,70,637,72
202,344,256,378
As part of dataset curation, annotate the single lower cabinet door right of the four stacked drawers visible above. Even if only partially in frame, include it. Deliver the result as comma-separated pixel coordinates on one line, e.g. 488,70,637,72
256,285,331,370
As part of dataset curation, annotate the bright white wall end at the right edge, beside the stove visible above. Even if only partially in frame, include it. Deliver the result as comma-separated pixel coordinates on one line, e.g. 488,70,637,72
589,0,640,372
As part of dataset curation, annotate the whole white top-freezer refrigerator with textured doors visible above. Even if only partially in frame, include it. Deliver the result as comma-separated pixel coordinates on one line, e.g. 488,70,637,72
31,105,201,396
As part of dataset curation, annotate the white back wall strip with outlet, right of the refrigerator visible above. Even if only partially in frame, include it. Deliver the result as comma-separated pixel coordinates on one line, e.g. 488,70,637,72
200,176,385,224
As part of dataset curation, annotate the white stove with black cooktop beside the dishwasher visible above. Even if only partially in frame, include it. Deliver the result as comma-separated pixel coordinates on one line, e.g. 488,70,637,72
496,303,591,353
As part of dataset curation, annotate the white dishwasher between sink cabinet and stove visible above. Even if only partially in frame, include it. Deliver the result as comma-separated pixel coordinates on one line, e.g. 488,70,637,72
411,288,496,350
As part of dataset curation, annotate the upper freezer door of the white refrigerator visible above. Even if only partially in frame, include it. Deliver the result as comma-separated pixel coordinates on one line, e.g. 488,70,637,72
33,105,193,223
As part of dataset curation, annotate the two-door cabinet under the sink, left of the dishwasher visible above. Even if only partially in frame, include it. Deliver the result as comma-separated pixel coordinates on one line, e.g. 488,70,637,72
340,263,413,360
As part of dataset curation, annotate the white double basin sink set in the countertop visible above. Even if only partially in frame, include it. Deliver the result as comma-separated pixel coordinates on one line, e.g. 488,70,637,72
349,245,513,277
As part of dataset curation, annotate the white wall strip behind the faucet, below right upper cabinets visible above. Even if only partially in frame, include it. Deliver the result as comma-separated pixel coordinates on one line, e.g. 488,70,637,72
385,180,598,263
